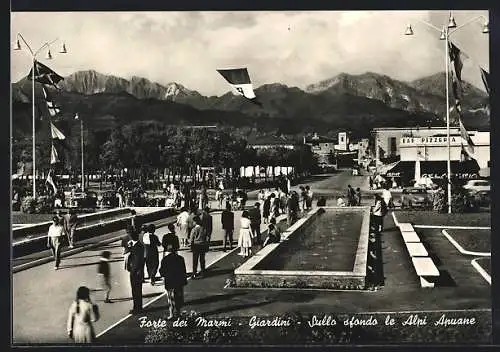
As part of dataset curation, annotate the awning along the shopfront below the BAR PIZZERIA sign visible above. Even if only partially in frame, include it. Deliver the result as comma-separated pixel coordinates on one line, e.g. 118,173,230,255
385,160,479,179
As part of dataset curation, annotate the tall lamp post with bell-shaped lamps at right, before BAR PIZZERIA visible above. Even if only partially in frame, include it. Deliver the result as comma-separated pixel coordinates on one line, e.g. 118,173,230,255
405,11,489,214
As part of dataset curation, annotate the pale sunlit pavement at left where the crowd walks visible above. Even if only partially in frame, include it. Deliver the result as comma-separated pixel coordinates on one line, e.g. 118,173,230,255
12,211,264,344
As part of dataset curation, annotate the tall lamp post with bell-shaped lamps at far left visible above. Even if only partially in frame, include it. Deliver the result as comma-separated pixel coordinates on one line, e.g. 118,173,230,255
14,33,67,198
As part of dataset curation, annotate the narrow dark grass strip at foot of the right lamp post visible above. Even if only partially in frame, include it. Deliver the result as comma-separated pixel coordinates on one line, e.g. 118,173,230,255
395,210,491,226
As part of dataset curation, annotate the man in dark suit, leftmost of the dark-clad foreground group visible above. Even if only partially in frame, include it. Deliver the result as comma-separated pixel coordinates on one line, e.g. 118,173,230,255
127,231,145,314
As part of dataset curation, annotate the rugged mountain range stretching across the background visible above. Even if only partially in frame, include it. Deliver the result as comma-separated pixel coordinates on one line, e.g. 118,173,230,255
12,70,489,137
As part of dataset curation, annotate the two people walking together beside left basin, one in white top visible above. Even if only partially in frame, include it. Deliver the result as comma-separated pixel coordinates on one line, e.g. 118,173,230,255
47,210,78,270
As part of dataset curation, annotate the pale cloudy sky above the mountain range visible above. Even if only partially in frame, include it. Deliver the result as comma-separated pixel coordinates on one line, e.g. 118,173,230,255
11,11,489,95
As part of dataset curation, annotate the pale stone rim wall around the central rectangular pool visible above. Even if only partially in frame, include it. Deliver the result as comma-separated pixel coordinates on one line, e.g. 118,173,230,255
234,207,370,290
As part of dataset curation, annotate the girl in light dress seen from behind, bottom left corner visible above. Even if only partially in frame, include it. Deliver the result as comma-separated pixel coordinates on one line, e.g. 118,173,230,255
67,286,99,343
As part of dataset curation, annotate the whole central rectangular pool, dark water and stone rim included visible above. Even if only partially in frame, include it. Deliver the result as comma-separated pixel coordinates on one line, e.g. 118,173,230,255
235,207,370,289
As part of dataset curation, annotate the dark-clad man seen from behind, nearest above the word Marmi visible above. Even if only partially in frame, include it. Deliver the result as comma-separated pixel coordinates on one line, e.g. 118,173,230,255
160,242,187,320
